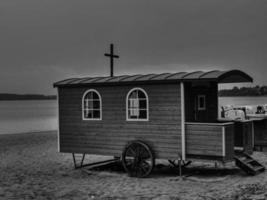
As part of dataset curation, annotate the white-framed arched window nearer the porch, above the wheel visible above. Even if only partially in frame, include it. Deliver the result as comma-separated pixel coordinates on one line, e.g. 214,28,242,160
126,88,148,121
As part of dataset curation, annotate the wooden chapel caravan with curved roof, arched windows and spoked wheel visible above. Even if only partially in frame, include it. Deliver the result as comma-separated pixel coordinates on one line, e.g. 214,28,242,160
54,70,264,177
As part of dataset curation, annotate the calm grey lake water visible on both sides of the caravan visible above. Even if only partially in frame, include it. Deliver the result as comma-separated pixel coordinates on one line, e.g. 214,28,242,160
0,97,267,134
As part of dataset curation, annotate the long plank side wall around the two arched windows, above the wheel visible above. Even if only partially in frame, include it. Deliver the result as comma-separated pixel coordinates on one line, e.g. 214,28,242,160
58,84,181,159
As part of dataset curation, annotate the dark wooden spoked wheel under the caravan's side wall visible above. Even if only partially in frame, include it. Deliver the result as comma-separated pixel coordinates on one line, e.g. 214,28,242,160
122,141,155,178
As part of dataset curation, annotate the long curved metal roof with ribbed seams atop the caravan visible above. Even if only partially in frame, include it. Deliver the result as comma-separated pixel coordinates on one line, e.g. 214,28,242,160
54,70,253,87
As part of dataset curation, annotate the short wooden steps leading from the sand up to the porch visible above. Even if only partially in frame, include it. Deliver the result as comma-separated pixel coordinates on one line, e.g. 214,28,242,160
234,152,265,176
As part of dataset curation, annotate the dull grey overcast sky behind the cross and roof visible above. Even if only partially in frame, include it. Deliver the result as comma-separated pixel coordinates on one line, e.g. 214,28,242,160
0,0,267,94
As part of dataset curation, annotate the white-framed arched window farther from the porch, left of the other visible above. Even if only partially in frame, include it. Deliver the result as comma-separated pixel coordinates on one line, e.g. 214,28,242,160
82,89,102,120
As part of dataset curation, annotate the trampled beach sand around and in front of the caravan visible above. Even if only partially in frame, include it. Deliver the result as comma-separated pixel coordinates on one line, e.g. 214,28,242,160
0,132,267,200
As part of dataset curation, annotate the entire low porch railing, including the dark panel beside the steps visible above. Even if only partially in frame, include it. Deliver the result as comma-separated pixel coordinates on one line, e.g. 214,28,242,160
185,121,253,162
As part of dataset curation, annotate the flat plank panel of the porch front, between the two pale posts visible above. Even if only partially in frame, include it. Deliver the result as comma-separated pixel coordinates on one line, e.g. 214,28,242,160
185,123,223,156
